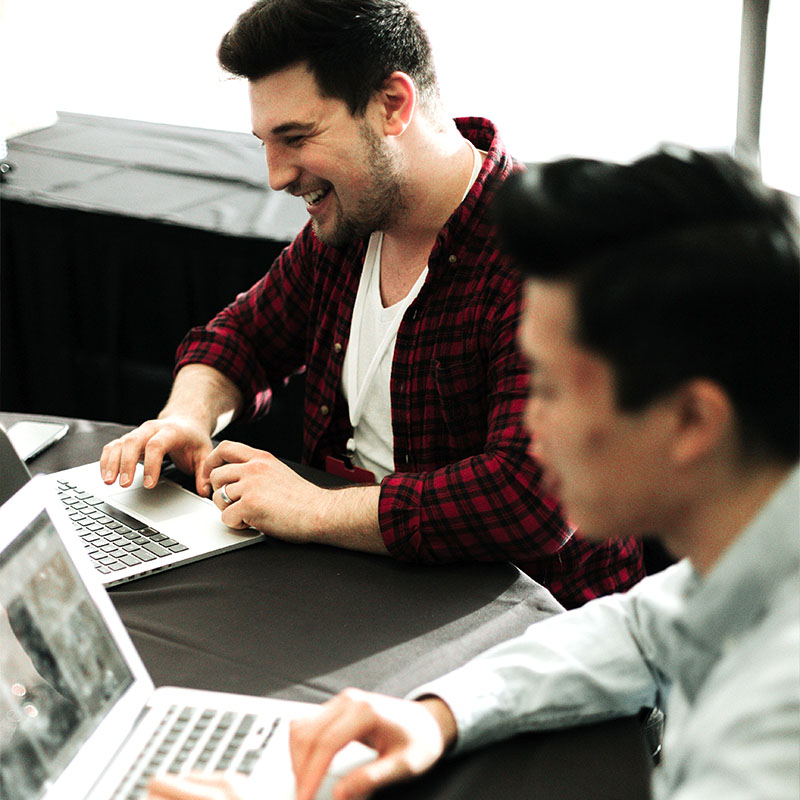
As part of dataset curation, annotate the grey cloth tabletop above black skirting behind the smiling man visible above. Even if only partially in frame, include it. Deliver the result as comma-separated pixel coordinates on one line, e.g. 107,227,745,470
2,112,308,241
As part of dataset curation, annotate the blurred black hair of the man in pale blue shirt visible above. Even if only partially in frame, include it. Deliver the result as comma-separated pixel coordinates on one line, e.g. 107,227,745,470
495,147,800,462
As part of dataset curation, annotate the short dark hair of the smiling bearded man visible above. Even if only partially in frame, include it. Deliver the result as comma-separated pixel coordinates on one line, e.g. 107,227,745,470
217,0,439,116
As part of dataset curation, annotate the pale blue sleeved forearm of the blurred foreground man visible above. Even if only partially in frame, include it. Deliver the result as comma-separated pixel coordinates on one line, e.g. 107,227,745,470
410,572,670,749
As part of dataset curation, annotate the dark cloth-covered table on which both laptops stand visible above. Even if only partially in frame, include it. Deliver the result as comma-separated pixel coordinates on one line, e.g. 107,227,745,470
0,413,650,800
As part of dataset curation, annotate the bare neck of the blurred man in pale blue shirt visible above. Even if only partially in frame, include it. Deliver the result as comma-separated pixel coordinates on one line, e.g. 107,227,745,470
664,465,791,575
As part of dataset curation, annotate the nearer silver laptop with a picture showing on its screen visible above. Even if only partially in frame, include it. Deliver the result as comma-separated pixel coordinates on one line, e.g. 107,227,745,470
0,476,374,800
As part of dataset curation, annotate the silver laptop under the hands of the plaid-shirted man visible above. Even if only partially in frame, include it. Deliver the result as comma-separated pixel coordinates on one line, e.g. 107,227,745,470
0,426,263,586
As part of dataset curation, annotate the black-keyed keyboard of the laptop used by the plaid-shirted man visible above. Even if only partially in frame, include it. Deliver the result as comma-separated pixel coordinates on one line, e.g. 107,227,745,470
57,480,188,575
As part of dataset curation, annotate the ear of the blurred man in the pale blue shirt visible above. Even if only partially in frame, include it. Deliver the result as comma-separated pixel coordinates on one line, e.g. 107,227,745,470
672,378,735,466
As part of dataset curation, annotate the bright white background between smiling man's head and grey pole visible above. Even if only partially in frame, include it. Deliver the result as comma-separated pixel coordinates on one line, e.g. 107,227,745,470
417,0,739,160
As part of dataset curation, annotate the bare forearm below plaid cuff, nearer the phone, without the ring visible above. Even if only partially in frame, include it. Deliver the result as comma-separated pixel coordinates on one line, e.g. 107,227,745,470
158,364,243,436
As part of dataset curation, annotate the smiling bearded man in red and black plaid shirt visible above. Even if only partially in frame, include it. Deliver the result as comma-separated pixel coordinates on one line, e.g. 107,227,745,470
101,0,643,607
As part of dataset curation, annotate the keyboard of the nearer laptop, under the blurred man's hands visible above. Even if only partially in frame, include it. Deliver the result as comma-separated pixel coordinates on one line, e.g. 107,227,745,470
112,705,280,800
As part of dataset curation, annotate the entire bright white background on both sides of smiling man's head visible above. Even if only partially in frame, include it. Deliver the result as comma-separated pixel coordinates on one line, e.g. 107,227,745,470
0,0,800,194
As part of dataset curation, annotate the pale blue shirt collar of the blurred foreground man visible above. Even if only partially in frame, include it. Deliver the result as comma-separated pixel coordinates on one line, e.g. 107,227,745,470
675,467,800,702
